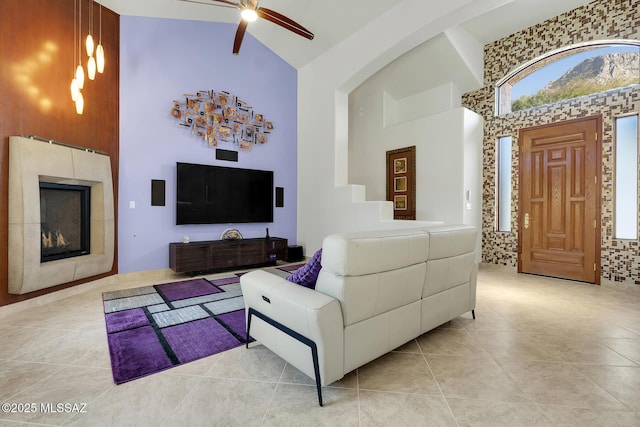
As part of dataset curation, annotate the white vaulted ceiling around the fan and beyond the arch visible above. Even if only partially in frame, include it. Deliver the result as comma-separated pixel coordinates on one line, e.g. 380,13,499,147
97,0,589,68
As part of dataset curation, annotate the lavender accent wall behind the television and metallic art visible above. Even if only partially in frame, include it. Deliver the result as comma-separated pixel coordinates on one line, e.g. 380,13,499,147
119,16,297,273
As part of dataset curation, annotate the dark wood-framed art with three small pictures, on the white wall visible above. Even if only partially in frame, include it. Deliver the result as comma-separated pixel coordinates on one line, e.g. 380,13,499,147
387,145,416,219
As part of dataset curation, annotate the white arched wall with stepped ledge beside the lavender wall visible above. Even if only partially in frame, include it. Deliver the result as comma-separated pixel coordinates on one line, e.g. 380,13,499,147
298,0,498,253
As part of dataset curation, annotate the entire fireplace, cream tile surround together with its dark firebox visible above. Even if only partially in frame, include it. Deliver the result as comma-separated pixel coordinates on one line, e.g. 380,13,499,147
8,136,115,295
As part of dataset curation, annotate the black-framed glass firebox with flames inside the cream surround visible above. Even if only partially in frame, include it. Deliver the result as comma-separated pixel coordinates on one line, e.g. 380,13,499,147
40,182,91,262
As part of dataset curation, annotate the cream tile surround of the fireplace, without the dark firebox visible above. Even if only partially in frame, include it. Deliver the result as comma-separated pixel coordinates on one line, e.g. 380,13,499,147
9,136,115,294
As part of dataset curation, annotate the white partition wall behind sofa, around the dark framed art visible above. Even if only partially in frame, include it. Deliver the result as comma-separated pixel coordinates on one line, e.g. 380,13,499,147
349,96,483,226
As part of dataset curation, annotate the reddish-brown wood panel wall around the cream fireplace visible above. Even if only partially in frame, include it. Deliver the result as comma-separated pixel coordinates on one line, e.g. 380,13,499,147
0,0,120,306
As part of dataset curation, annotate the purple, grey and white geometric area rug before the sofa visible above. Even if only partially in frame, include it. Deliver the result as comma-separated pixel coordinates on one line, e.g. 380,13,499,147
102,264,303,384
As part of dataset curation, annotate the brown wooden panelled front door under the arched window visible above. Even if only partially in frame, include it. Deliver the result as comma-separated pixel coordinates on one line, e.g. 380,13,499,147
518,117,601,284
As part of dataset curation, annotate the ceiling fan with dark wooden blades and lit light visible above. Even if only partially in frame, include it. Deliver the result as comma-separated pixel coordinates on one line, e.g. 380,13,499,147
183,0,313,55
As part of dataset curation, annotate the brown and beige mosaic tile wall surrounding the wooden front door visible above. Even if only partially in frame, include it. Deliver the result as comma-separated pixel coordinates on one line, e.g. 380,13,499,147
462,0,640,285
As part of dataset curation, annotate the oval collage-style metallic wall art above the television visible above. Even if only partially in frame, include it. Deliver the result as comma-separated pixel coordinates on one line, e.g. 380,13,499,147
171,90,273,151
